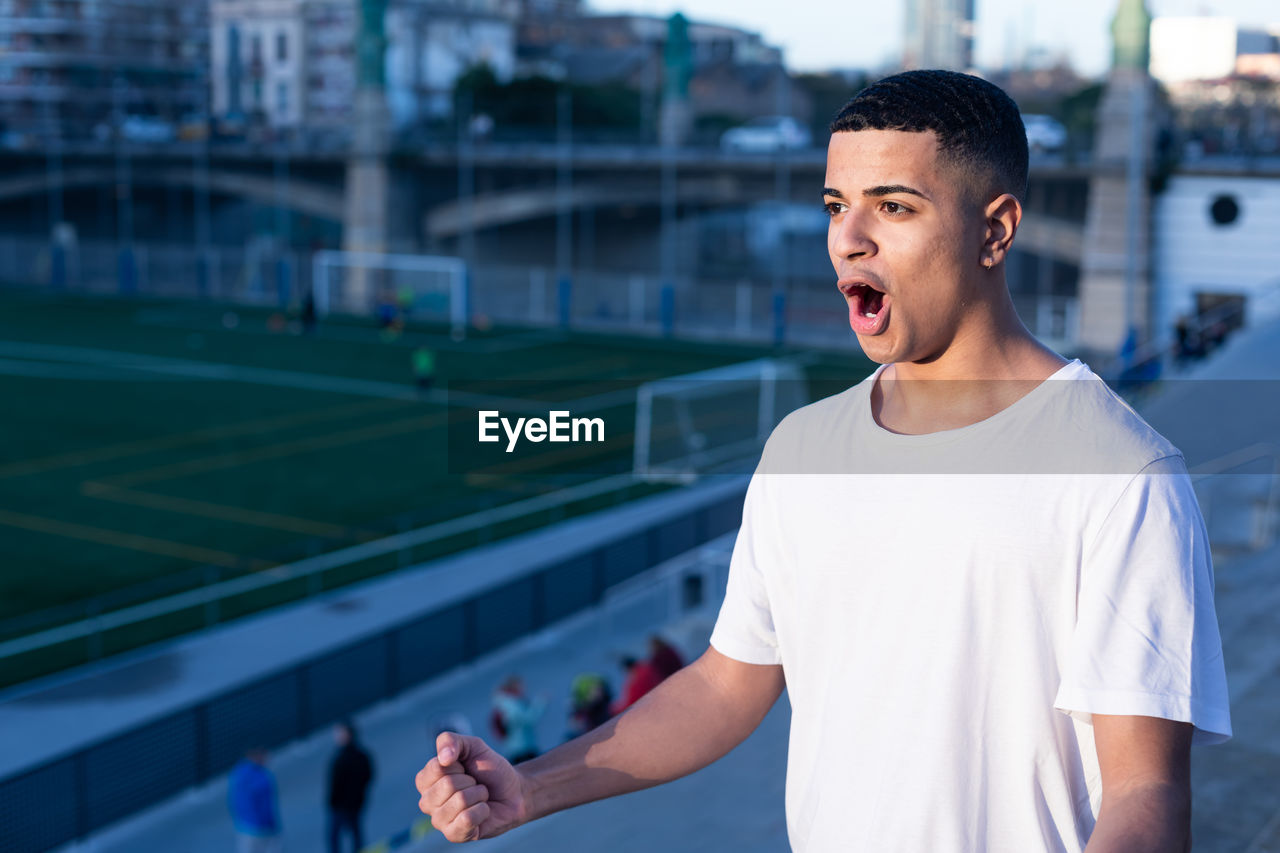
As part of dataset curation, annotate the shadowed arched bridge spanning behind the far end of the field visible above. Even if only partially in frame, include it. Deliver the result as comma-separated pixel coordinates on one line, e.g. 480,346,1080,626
0,142,1091,264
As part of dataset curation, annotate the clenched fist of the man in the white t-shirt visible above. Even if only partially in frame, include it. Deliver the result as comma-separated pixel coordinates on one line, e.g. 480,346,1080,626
416,731,530,841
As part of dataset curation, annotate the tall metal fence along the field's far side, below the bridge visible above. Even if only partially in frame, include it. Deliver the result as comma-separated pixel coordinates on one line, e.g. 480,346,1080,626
0,238,1079,347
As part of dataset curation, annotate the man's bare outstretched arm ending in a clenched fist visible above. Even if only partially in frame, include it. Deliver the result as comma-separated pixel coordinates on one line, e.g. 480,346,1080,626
417,648,783,841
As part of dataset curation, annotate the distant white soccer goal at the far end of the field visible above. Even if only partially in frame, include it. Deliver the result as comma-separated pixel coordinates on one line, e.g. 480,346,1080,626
311,250,467,333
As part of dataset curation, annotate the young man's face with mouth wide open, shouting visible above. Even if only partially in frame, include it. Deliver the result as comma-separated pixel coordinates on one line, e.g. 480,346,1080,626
823,131,984,364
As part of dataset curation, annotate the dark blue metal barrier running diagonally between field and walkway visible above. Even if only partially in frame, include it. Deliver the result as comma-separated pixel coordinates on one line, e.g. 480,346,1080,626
0,491,742,853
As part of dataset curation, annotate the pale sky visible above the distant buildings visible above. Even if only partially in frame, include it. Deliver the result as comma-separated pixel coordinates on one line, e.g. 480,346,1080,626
590,0,1280,76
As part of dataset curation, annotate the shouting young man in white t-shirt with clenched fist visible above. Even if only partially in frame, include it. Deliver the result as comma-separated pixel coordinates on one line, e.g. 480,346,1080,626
417,72,1230,853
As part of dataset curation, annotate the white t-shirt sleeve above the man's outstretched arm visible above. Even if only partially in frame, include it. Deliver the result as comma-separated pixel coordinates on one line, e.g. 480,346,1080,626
712,465,782,665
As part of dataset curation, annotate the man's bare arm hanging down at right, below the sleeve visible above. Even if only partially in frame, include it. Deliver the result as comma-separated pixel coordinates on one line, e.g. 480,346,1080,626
1085,713,1192,853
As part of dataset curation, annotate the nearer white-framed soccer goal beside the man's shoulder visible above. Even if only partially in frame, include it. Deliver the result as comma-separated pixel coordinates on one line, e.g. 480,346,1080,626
634,359,809,483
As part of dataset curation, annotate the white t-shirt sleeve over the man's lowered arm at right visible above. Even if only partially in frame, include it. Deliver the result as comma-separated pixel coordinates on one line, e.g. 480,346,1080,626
1053,456,1231,744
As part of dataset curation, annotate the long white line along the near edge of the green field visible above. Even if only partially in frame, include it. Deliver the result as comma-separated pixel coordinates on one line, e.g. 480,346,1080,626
0,471,636,660
